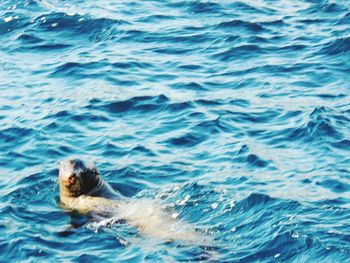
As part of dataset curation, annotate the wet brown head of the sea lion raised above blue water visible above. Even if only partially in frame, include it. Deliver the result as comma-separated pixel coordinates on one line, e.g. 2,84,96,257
58,159,100,197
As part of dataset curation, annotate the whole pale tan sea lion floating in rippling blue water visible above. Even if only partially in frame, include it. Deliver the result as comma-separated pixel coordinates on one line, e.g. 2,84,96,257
59,159,199,243
